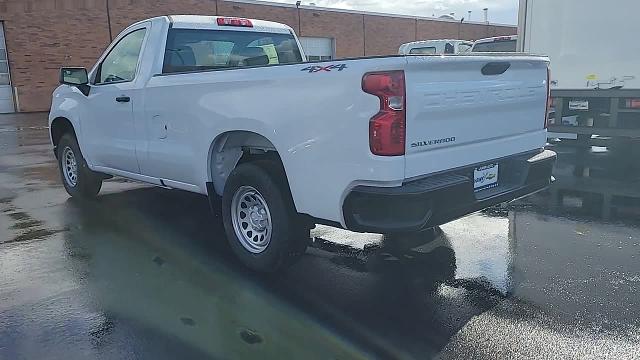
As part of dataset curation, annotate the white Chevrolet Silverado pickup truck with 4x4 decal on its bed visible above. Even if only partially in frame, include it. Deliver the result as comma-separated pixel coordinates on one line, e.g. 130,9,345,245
49,15,555,271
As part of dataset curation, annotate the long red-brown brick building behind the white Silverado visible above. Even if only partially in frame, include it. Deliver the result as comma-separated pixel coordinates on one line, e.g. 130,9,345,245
0,0,516,111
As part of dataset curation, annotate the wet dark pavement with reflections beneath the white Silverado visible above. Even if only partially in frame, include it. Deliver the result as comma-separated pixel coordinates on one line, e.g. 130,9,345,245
0,114,640,359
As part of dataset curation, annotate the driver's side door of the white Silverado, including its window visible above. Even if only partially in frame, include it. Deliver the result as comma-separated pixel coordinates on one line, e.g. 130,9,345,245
82,24,147,173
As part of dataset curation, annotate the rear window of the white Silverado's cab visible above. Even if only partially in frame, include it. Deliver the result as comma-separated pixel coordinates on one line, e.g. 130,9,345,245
162,29,302,74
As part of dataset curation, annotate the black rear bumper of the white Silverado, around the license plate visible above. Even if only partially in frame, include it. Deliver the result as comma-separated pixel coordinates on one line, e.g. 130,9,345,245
342,150,556,233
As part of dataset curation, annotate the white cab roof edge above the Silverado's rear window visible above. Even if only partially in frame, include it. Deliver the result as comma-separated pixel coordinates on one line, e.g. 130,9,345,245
167,15,293,34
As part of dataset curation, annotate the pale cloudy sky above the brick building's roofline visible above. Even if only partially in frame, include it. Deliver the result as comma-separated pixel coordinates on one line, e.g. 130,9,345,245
268,0,518,25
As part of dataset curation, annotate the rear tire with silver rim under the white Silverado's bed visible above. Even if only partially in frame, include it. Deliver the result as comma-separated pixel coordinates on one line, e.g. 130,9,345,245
222,160,309,273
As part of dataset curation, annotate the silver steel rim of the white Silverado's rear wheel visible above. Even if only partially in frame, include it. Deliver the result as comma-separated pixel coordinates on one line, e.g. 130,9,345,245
231,186,273,254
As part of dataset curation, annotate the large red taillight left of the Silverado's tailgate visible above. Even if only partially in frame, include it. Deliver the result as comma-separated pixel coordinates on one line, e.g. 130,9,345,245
362,71,406,156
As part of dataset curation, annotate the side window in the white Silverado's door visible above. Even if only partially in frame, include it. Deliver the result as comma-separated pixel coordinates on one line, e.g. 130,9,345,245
96,29,146,83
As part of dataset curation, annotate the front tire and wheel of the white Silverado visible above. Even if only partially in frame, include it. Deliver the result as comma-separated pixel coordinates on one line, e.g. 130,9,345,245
57,133,102,199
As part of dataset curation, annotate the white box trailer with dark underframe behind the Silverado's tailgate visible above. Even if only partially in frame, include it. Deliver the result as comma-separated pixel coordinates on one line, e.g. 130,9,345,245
518,0,640,138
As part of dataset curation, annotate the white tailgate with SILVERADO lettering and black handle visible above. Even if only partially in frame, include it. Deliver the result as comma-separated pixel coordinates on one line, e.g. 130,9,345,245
405,55,548,178
